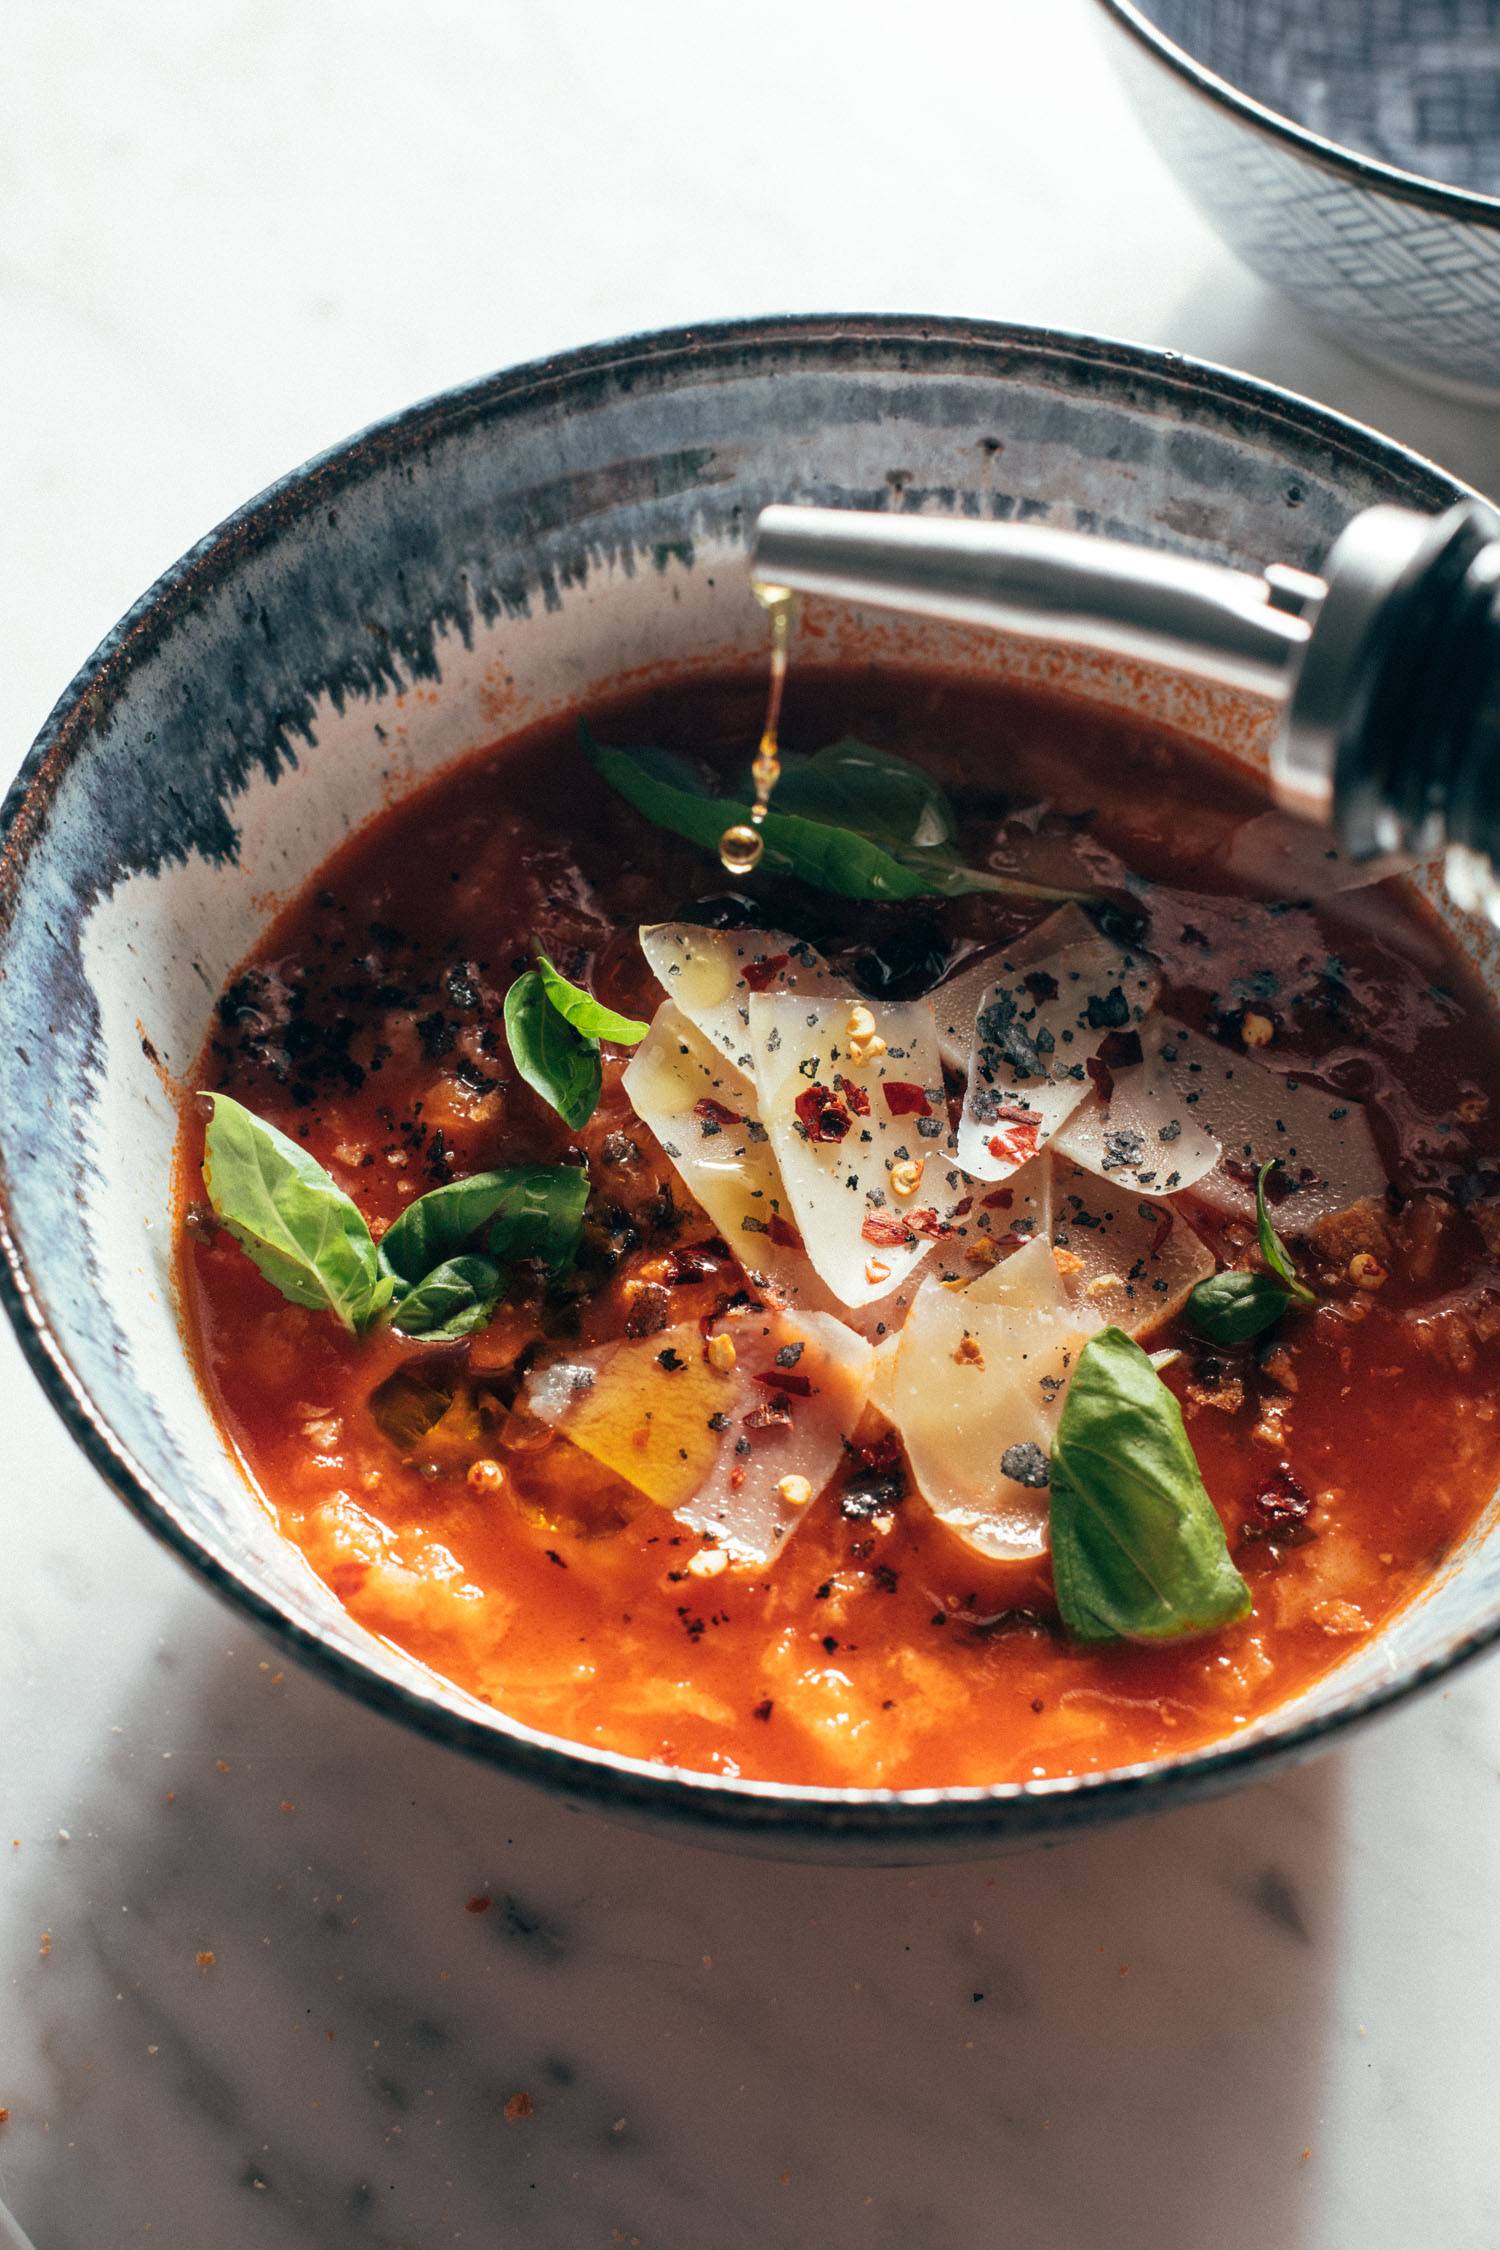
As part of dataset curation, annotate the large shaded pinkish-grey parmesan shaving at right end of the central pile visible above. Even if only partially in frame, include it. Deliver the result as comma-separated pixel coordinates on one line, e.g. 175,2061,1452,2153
1137,1024,1385,1235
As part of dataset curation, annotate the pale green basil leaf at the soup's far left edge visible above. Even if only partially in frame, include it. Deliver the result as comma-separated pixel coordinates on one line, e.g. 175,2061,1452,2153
202,1094,386,1334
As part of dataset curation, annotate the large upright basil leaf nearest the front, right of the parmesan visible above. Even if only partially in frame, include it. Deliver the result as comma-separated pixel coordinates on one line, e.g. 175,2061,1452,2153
1050,1328,1250,1640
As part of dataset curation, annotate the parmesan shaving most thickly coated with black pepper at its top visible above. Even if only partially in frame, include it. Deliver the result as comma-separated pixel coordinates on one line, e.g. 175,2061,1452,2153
958,929,1158,1179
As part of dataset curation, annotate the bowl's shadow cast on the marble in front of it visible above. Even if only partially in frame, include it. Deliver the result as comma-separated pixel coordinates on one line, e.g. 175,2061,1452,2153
0,1600,1340,2250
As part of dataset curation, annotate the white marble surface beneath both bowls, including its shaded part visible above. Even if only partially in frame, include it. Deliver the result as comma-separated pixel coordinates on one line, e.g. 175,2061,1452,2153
0,0,1500,2250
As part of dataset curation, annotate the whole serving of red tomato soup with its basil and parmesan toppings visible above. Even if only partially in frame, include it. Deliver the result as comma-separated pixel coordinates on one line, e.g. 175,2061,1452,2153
180,671,1500,1787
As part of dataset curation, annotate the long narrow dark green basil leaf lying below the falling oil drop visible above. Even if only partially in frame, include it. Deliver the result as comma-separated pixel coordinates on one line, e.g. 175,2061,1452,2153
582,727,1086,902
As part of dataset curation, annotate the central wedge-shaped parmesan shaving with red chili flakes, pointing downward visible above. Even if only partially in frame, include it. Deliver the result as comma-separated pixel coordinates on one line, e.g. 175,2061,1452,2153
749,992,965,1305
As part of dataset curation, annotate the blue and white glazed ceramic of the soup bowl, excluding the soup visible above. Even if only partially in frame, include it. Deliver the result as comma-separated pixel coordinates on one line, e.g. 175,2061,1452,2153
0,317,1500,1861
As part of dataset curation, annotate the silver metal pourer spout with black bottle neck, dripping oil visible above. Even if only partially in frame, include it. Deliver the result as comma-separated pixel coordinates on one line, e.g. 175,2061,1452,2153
751,502,1500,923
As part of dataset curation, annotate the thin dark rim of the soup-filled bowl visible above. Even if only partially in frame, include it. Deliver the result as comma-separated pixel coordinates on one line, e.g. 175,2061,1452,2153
0,313,1500,1854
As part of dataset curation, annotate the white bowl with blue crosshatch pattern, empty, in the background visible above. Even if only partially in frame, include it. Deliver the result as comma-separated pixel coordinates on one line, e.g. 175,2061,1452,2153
1100,0,1500,403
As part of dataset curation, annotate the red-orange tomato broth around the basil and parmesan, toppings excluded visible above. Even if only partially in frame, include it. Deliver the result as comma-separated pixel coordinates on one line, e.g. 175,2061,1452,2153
180,671,1500,1787
